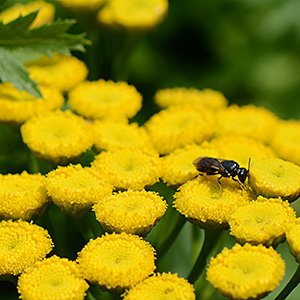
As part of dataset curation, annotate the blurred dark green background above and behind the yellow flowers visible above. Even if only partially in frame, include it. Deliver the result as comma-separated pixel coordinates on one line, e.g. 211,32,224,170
69,0,300,119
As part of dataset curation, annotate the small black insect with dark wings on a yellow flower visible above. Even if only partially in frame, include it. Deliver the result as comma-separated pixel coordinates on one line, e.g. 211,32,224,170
193,156,250,189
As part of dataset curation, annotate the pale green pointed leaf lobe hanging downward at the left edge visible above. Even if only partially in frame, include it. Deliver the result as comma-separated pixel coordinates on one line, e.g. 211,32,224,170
0,47,42,98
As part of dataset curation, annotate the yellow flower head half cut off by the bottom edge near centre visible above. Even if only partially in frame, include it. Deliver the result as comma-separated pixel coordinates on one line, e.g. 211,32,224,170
123,273,196,300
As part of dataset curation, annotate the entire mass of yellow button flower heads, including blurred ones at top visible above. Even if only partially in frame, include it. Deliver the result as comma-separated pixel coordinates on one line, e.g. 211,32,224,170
0,0,300,300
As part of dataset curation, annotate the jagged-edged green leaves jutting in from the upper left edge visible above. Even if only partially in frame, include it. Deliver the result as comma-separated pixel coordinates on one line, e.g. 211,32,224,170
0,12,90,97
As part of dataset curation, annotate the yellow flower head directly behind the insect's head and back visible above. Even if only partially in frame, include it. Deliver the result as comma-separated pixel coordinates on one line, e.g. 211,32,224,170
210,135,275,168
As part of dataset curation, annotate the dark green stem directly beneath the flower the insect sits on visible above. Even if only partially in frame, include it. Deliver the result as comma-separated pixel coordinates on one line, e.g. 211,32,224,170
188,229,221,283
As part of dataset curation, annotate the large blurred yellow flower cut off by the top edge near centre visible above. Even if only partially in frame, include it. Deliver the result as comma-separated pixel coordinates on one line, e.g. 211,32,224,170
98,0,169,30
